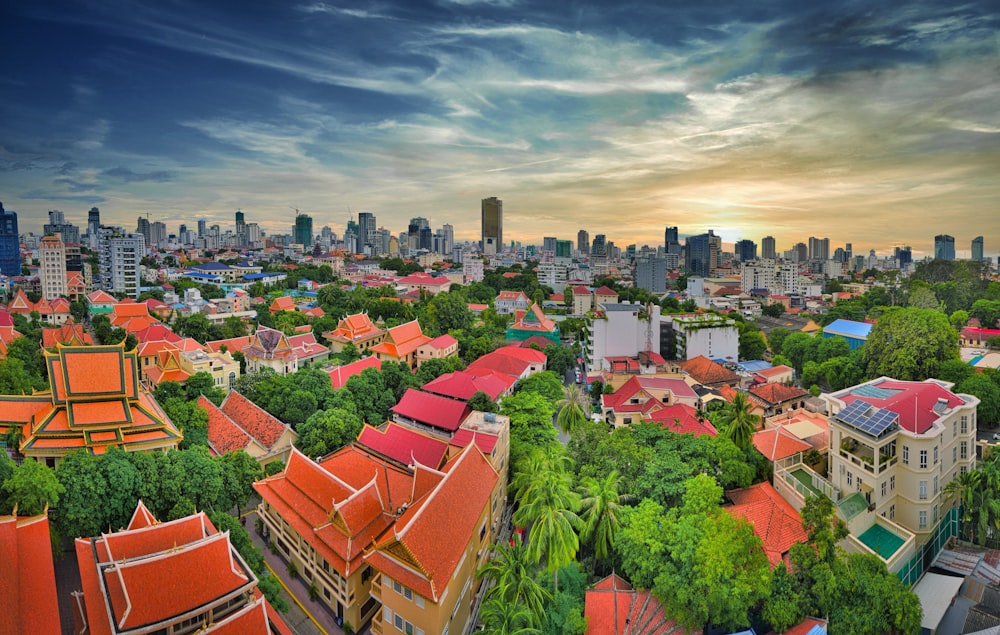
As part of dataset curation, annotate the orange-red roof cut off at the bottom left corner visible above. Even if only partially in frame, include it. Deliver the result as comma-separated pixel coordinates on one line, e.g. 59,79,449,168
0,510,62,635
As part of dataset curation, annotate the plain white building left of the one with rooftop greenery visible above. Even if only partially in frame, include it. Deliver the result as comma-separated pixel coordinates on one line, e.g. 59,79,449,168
587,303,660,371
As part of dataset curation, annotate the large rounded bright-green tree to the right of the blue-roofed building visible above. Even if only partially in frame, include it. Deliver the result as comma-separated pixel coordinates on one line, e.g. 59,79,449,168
864,308,958,381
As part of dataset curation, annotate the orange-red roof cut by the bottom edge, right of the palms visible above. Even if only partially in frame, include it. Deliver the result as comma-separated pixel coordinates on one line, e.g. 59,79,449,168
583,574,701,635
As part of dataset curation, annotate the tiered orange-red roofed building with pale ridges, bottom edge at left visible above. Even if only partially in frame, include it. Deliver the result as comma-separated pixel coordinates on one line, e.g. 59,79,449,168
73,501,292,635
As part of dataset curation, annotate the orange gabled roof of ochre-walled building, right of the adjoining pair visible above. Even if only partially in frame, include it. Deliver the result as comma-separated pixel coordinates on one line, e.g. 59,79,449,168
365,445,499,602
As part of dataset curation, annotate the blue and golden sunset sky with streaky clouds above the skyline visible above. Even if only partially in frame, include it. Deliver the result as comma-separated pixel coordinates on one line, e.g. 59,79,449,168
0,0,1000,258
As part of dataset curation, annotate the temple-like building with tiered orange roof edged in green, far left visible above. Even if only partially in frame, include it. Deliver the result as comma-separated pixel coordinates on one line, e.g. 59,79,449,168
0,344,181,467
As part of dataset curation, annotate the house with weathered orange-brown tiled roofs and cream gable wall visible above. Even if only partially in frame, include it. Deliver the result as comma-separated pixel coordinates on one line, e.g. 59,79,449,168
198,390,299,467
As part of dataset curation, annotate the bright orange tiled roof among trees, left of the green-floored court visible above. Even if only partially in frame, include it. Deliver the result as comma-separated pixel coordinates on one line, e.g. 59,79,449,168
724,481,806,567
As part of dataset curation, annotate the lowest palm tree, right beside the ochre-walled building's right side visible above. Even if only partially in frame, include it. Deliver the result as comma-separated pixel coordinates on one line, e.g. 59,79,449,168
476,534,552,626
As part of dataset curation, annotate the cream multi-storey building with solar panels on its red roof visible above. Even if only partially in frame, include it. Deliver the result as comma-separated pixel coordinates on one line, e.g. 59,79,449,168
823,377,979,545
